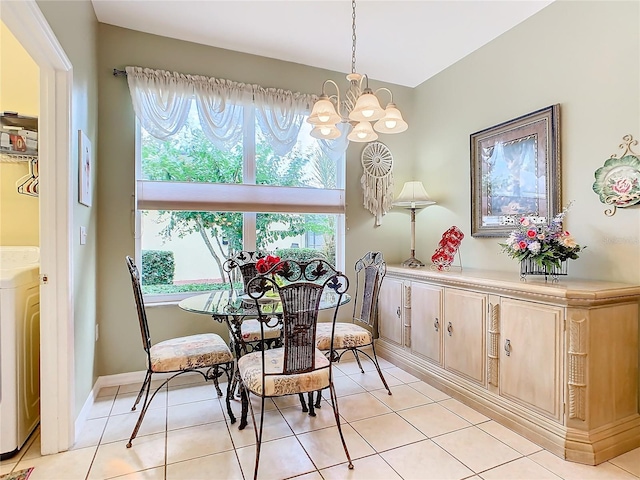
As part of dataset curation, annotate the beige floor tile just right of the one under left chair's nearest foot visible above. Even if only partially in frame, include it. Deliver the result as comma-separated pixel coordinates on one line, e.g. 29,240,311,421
167,421,233,463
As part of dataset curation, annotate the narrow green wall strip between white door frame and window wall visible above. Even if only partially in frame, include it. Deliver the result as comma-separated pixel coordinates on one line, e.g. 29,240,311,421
38,0,100,414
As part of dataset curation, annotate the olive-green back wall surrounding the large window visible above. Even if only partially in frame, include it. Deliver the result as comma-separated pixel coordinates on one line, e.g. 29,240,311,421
98,24,415,375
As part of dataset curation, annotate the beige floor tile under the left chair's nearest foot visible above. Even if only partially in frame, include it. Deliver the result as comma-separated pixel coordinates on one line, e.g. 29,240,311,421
89,433,166,480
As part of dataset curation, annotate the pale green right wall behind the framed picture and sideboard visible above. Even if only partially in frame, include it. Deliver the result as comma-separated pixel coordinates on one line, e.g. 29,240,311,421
411,1,640,283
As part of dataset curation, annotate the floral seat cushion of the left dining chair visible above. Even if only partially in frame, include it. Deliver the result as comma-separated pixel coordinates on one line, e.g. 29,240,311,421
149,333,233,372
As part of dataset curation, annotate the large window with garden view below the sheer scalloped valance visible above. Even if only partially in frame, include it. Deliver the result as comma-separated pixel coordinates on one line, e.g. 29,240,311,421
136,104,345,301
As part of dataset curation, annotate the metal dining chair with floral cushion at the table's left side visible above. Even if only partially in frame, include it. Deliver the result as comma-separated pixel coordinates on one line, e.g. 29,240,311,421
126,256,236,448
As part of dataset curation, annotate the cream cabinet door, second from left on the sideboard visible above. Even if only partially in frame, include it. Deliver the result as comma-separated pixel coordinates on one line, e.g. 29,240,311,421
410,282,443,365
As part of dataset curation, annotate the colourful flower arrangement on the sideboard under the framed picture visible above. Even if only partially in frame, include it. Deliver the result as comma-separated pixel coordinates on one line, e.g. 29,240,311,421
500,204,586,271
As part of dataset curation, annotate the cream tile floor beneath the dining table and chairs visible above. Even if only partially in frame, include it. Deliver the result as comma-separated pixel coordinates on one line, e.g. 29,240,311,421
0,356,640,480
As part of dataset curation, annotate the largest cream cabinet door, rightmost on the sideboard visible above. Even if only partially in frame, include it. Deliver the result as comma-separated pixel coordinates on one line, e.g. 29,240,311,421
500,298,563,421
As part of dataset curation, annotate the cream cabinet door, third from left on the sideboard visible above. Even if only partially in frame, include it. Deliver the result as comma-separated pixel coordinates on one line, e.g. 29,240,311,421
443,288,487,385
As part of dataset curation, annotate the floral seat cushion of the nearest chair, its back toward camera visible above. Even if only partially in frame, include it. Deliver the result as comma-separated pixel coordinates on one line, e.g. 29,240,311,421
238,348,329,397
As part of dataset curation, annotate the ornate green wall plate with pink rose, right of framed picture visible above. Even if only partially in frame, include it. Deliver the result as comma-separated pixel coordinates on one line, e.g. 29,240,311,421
593,135,640,216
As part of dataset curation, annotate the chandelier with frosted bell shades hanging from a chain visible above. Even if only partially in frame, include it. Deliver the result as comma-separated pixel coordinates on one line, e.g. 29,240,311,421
307,0,409,142
